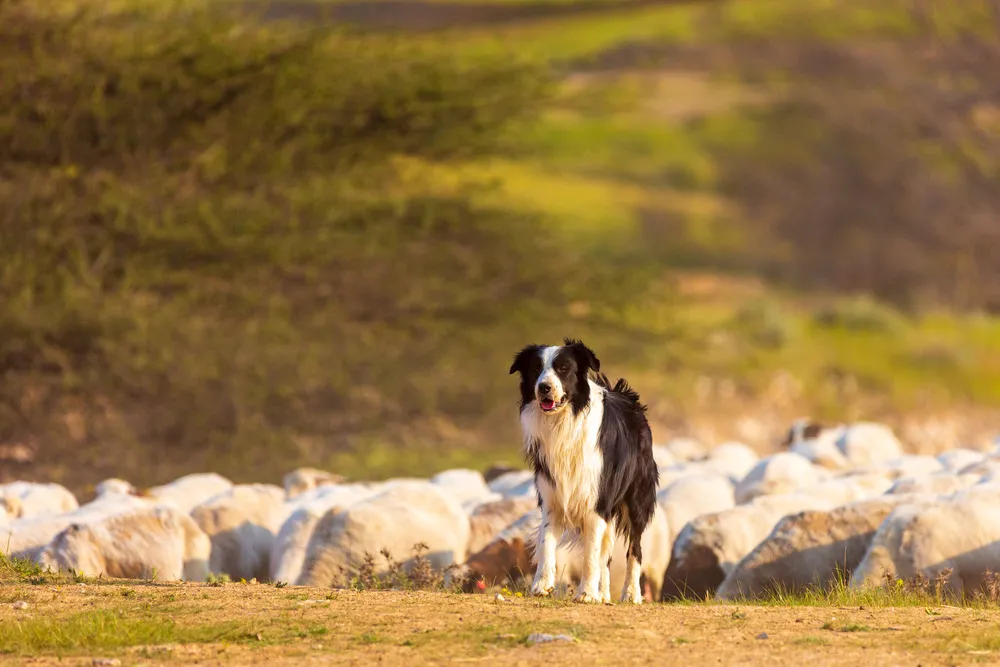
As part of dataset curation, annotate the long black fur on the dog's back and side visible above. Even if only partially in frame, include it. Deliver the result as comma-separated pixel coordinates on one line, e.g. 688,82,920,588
594,373,660,563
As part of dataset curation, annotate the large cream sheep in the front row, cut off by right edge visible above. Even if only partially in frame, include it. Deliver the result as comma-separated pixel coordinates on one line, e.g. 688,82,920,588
850,484,1000,595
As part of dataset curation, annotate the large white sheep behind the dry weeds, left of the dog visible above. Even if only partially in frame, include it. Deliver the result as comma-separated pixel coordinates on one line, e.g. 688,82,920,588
296,482,469,587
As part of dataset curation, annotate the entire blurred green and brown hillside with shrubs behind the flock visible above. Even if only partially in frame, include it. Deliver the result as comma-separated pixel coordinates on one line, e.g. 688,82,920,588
0,0,1000,488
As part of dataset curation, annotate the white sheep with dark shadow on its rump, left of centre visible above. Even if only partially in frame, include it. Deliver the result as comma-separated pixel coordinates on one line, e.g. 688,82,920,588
191,484,287,581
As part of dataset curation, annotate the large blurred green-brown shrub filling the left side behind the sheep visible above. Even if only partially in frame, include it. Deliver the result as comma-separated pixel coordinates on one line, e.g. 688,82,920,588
0,1,600,484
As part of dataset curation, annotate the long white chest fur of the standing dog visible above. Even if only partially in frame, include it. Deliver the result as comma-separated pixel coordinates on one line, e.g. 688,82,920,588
521,382,604,530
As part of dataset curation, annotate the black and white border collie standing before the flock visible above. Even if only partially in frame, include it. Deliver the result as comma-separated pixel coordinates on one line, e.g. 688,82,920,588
510,339,659,604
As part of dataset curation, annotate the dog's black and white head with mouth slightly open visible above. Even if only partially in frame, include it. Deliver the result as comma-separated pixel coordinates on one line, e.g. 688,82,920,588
510,338,601,415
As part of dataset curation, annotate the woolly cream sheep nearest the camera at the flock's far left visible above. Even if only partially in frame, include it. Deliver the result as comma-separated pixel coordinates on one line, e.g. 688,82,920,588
38,507,211,581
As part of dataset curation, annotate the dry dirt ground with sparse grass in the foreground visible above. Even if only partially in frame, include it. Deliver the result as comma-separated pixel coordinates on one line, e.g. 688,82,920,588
0,583,1000,667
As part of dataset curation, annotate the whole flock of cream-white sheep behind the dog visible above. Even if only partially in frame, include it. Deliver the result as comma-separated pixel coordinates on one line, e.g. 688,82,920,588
0,422,1000,600
